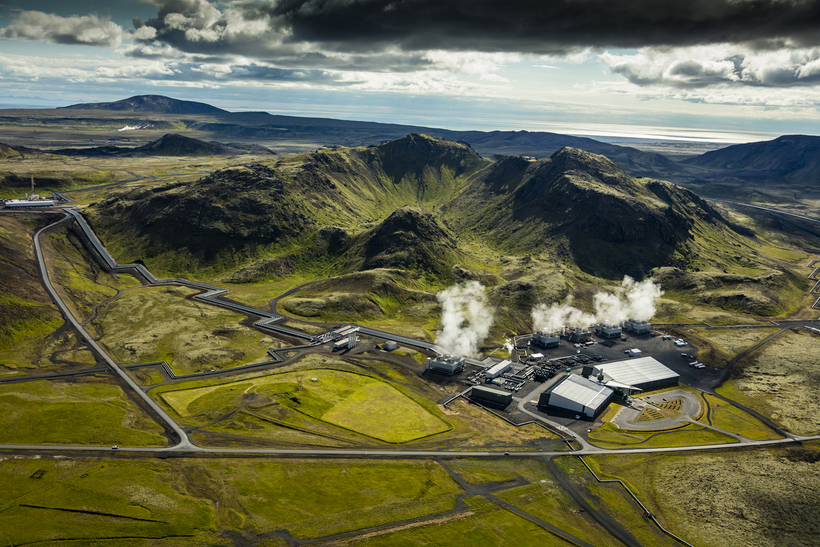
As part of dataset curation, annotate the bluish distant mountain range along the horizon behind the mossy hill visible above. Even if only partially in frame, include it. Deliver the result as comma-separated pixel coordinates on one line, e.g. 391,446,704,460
6,95,820,188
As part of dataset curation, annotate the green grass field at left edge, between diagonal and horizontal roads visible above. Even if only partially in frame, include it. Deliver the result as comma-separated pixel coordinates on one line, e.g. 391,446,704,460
0,376,166,446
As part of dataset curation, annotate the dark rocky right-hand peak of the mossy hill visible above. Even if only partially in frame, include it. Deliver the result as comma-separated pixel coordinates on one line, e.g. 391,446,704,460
445,148,748,277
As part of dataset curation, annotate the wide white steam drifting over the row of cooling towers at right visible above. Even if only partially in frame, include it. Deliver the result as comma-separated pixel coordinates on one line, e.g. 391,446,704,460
532,276,663,332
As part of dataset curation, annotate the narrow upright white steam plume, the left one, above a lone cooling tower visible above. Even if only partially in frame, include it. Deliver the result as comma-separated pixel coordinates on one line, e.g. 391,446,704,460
436,281,493,355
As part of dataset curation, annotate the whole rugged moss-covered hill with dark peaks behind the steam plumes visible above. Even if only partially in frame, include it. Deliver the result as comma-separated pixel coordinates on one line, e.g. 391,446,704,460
85,134,756,282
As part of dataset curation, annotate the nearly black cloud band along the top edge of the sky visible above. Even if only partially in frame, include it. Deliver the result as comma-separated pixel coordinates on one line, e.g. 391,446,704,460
232,0,820,53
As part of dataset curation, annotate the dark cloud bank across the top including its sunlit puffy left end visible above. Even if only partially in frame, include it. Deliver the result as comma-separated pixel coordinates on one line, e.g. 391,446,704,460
135,0,820,60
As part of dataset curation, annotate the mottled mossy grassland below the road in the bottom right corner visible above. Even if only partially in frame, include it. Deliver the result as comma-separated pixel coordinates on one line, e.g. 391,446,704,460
586,443,820,547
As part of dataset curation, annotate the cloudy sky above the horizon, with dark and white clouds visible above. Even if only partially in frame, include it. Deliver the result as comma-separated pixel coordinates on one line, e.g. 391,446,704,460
0,0,820,142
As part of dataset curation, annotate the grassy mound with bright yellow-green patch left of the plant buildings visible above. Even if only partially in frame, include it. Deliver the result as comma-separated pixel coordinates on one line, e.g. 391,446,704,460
150,354,556,450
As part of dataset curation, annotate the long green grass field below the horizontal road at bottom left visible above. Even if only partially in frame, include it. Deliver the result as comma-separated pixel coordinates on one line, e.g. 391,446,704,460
0,458,468,545
